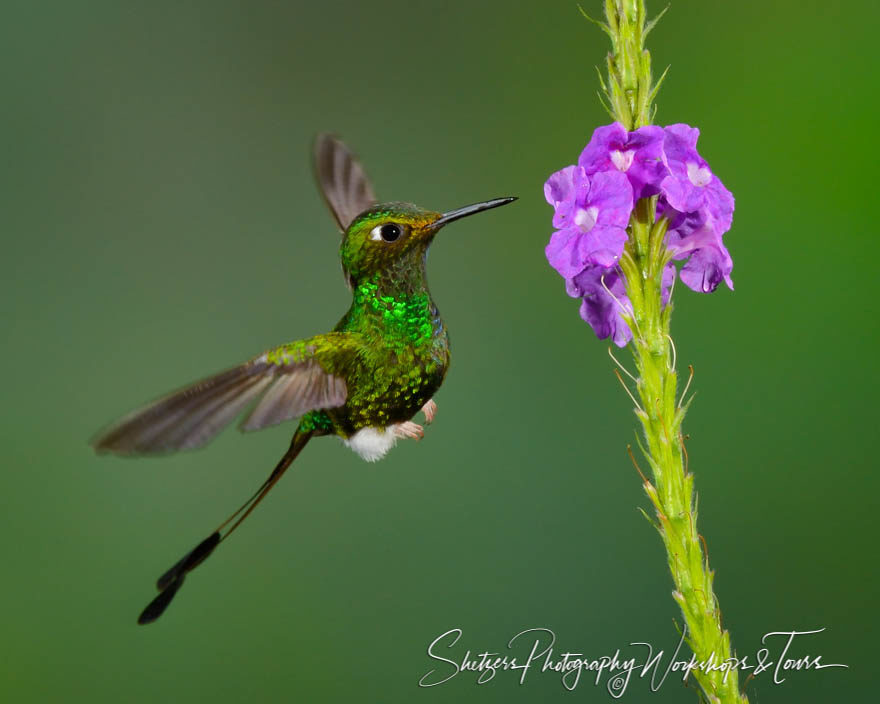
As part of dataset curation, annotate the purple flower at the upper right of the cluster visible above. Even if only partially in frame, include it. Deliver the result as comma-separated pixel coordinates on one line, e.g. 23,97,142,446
660,124,733,232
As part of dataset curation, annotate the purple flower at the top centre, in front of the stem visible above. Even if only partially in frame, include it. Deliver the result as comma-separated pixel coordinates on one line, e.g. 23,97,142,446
578,122,668,200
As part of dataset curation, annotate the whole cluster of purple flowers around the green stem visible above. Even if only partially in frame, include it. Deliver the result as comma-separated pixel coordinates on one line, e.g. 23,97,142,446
544,122,733,347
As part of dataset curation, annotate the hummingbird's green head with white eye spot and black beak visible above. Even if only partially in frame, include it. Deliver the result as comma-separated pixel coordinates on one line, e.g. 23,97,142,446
341,198,516,284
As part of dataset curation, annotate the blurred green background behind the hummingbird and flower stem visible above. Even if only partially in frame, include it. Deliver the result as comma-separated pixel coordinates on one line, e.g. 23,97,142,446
0,0,880,702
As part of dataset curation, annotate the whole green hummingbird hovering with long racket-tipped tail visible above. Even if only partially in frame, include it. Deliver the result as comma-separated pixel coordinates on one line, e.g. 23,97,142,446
92,134,516,624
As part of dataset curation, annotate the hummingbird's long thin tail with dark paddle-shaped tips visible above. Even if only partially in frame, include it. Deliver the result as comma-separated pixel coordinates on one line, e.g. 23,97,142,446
138,430,312,625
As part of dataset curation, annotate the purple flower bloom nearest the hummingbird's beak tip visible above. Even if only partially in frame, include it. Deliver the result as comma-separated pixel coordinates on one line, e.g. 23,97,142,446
544,166,633,279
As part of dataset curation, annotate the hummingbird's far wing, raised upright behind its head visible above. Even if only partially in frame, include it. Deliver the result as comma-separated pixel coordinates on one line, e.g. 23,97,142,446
315,134,376,232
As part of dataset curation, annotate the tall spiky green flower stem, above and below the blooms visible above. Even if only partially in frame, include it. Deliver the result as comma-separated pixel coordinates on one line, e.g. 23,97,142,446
602,0,748,704
